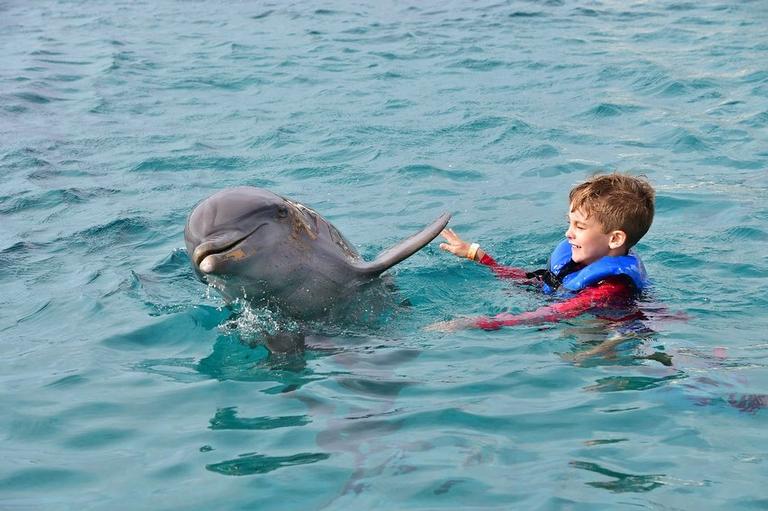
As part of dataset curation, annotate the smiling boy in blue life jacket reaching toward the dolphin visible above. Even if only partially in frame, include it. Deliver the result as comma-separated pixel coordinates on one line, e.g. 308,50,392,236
427,173,655,331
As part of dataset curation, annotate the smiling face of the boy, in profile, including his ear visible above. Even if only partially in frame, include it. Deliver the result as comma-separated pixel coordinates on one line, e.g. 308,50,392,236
565,208,626,265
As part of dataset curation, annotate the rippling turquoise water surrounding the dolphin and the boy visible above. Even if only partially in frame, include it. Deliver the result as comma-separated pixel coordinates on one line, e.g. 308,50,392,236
0,0,768,510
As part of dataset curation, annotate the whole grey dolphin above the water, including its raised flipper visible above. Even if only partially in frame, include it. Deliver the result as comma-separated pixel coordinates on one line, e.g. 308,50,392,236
184,186,451,319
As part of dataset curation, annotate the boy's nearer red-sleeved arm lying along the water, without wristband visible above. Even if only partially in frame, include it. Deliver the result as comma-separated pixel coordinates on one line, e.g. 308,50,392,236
426,278,631,332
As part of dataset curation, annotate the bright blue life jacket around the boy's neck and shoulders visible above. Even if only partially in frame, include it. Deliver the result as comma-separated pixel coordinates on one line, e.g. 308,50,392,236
531,240,648,294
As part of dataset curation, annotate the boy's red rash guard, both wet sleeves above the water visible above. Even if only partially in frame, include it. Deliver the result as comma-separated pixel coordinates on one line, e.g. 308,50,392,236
474,254,635,330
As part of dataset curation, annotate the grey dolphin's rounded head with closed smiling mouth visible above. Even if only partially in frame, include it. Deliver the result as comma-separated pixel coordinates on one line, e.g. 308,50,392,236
184,187,312,298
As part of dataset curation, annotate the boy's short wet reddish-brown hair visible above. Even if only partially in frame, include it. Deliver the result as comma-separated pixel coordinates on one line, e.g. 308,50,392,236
569,172,656,248
